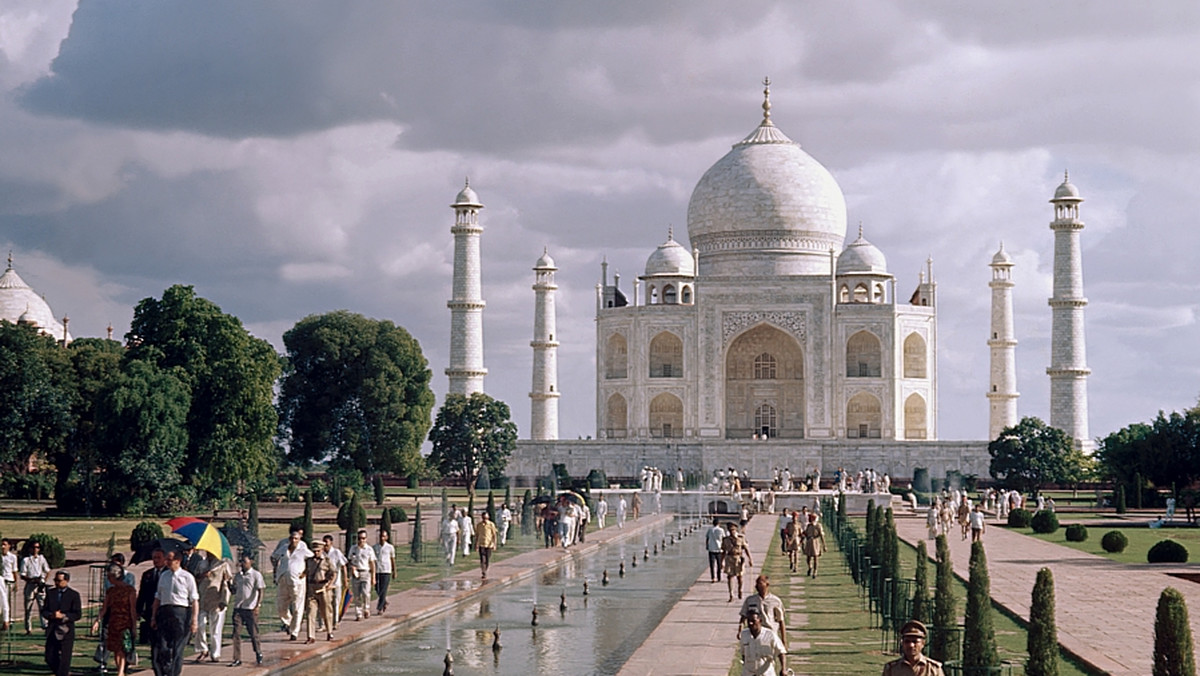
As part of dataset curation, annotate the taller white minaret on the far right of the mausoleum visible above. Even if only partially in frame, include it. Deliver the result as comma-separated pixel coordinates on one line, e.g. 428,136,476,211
1046,174,1093,450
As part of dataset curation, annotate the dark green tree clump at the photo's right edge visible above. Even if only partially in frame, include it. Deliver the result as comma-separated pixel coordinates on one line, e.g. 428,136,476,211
1096,406,1200,487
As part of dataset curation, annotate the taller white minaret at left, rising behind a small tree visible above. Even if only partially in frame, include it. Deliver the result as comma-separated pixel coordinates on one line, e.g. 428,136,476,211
446,180,487,395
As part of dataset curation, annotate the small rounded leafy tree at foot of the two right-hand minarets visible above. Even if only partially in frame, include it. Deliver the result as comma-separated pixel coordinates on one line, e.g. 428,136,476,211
988,418,1090,495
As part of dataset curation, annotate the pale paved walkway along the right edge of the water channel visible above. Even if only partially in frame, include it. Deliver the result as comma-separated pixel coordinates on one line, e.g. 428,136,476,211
619,514,779,676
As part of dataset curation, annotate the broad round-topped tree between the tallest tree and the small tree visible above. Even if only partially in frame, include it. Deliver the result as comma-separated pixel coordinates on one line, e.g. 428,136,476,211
280,310,433,474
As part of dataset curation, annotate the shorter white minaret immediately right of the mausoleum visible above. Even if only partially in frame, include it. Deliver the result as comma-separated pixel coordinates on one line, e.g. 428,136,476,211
988,243,1020,441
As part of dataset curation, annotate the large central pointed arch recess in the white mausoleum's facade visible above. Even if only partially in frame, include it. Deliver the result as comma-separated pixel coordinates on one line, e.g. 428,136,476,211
725,324,804,438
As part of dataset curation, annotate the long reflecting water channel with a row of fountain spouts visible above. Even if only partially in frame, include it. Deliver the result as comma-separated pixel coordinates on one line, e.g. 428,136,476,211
304,520,707,676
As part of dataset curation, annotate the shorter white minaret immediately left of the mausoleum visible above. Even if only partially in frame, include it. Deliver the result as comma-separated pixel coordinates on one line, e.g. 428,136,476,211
529,250,559,441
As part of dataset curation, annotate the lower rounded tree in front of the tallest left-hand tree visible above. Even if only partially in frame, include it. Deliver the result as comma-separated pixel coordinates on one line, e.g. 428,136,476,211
97,360,191,512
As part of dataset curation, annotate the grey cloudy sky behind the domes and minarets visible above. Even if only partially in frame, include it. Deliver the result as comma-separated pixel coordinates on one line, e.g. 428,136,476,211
0,0,1200,439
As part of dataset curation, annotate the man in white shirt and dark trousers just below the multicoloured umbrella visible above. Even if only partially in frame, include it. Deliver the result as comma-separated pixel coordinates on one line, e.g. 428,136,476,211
150,551,200,676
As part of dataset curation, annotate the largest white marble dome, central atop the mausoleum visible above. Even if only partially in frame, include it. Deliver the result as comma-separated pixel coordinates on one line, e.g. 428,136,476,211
688,102,846,276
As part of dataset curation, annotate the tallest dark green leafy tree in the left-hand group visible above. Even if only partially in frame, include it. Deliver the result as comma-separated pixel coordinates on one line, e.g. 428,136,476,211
126,285,281,492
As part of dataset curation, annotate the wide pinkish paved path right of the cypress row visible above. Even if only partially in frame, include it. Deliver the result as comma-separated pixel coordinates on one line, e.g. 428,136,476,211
896,514,1200,676
